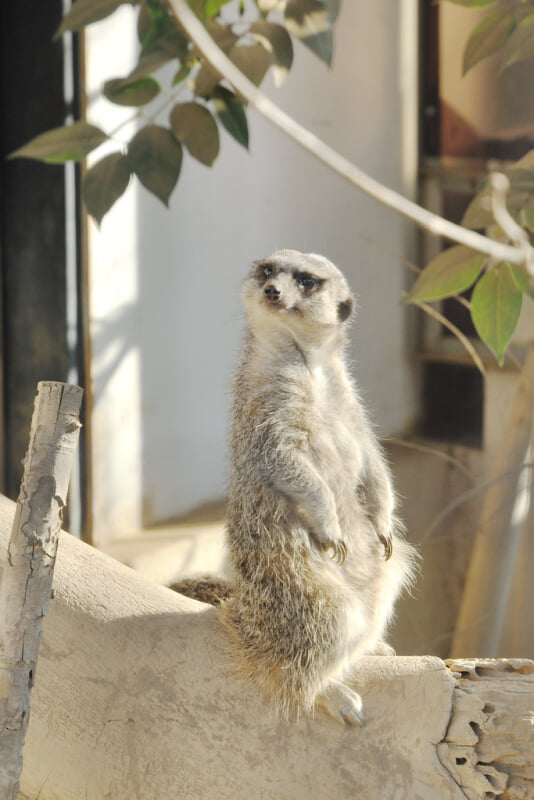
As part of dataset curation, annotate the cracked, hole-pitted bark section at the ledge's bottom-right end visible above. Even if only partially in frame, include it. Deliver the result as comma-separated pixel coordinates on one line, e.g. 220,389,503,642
437,658,534,800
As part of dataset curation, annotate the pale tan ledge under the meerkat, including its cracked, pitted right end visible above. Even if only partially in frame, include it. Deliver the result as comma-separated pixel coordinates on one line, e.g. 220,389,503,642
0,498,534,800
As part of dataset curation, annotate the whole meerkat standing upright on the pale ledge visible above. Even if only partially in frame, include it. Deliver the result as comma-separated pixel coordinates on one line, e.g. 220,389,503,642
173,250,415,725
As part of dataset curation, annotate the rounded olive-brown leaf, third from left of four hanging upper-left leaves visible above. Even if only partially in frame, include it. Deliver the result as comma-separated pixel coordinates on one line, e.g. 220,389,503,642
170,103,219,166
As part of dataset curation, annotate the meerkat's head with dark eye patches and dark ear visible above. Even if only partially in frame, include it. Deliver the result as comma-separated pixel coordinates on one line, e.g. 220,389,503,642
242,250,354,338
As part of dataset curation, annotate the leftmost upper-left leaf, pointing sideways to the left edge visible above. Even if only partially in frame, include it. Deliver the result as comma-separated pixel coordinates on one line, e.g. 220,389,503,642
9,122,108,164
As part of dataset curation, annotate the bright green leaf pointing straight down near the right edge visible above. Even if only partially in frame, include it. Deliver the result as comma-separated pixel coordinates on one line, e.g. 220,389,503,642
471,264,523,365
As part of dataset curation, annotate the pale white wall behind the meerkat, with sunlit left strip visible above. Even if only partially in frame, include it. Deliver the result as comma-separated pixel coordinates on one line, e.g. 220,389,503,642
89,0,417,540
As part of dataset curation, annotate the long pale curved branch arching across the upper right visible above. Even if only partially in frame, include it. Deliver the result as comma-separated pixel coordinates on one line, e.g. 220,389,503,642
170,0,531,268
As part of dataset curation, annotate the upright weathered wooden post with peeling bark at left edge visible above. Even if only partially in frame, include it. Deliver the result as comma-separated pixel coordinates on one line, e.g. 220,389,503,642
0,382,83,800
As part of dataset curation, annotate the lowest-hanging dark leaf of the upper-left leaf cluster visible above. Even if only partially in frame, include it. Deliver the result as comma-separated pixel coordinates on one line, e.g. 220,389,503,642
82,153,130,225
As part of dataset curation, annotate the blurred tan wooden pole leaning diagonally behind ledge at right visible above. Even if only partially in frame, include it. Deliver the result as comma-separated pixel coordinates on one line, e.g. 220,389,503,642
451,347,534,658
